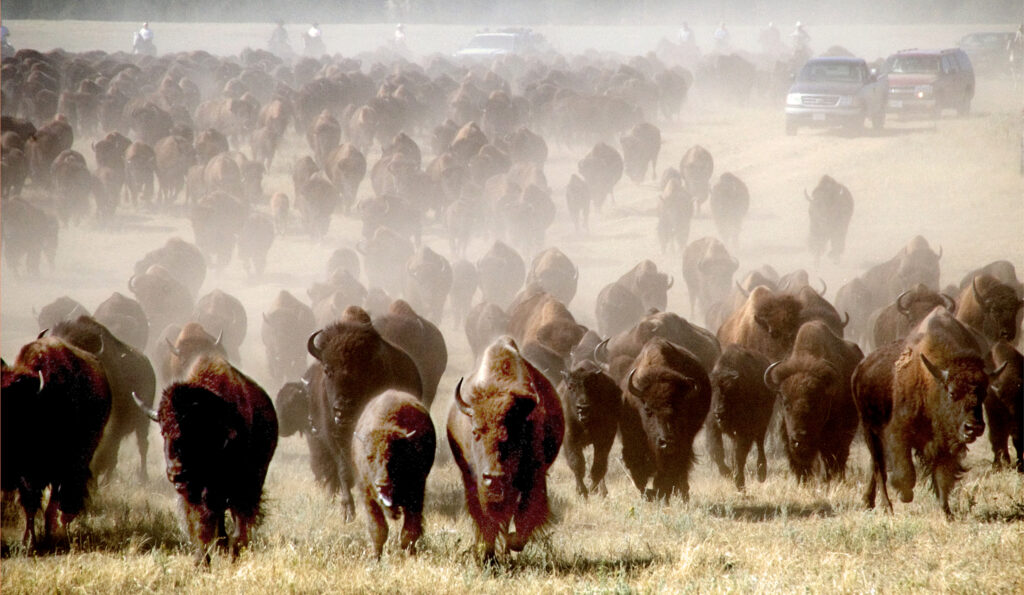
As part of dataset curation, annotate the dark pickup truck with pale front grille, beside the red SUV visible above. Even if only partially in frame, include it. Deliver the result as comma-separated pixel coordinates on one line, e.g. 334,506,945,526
785,57,889,134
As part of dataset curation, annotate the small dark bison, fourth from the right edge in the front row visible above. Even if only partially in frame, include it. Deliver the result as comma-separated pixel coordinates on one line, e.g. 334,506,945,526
705,345,775,491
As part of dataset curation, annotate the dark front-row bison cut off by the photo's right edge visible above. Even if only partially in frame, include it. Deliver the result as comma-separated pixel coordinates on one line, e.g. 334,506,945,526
985,340,1024,473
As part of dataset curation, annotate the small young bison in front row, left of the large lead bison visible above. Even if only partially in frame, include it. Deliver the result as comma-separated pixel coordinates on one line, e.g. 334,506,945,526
352,390,437,558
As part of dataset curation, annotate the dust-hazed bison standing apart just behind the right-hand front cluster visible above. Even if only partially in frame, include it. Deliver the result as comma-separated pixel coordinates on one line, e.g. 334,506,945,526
683,238,739,315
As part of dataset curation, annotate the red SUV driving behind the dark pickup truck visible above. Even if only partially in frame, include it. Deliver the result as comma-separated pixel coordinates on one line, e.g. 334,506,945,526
885,48,974,118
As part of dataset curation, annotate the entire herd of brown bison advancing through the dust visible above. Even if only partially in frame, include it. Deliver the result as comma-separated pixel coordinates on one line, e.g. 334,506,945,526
0,39,1024,563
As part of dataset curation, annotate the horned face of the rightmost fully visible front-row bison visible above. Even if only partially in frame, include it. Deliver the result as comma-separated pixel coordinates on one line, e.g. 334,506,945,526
921,353,1002,444
